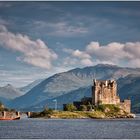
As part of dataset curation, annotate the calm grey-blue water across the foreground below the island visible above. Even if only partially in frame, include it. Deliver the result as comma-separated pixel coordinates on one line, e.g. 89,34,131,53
0,115,140,139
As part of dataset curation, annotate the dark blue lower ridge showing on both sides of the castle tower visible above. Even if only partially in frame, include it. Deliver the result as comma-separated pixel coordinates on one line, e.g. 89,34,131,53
21,74,140,113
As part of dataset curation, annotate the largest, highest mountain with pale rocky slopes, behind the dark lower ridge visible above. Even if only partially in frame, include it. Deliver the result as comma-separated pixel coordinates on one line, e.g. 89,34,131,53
9,64,140,109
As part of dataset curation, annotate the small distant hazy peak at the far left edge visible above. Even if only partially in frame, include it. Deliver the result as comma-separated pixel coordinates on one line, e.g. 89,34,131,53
0,84,22,105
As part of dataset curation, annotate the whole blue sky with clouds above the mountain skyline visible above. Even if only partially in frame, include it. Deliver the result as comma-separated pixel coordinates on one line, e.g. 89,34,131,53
0,1,140,87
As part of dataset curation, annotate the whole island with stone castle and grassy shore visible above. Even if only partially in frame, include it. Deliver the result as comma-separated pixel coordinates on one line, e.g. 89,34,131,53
30,79,135,119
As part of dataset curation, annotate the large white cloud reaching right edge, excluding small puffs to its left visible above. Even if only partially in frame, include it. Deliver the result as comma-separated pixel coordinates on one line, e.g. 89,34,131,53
85,42,140,67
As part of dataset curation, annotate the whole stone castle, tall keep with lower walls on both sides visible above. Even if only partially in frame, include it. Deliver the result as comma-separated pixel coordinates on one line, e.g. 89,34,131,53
73,79,131,113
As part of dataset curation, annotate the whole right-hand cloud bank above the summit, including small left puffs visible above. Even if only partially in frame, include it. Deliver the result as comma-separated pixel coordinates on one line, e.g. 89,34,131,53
65,42,140,67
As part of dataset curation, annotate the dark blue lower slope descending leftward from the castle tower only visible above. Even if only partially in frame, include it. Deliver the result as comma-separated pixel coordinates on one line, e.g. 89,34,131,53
21,86,91,111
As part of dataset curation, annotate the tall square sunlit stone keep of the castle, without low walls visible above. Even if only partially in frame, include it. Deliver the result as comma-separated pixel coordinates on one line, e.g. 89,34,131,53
92,80,120,105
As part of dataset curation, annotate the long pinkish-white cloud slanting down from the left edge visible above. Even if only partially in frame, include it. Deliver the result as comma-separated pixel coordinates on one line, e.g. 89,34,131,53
0,25,57,69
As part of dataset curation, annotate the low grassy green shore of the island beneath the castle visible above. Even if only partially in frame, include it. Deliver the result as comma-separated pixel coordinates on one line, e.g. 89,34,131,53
30,104,135,119
